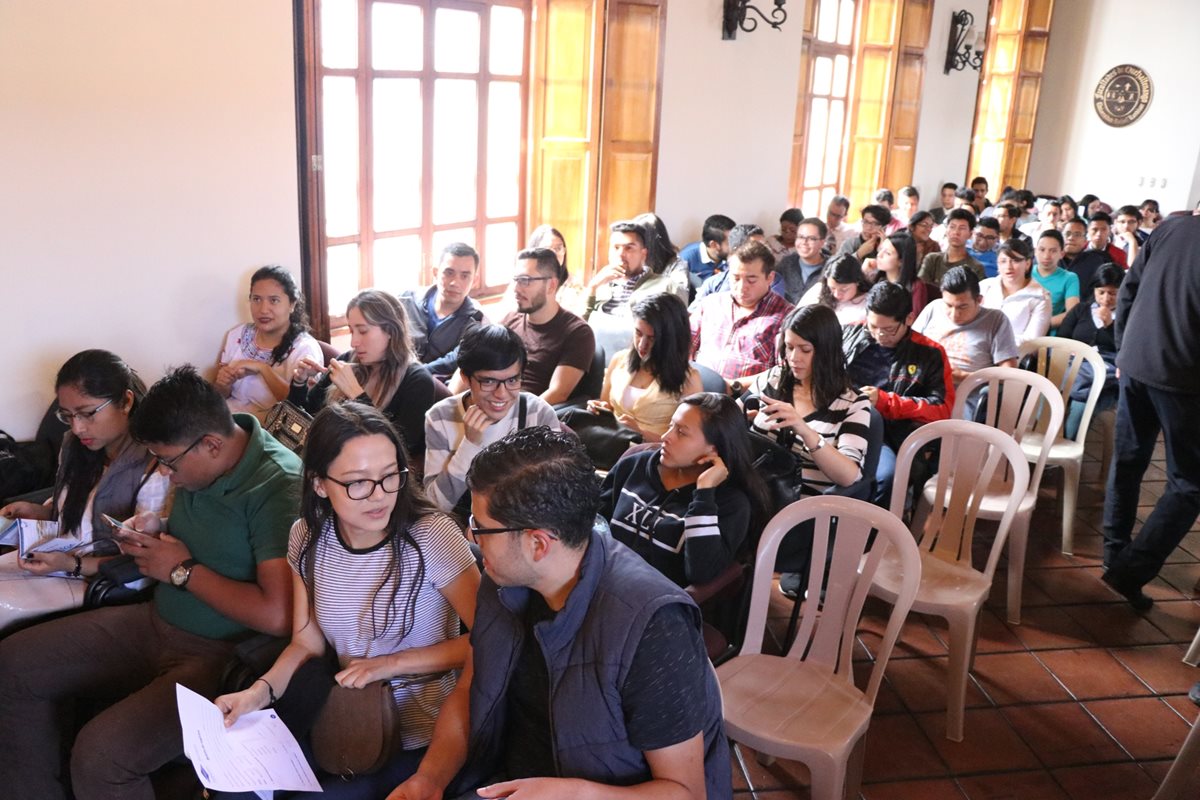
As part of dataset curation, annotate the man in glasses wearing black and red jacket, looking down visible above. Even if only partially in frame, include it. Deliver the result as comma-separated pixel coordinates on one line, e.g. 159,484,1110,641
841,281,954,503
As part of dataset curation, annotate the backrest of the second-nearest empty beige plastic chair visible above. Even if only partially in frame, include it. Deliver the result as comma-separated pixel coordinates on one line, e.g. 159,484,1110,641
892,420,1030,582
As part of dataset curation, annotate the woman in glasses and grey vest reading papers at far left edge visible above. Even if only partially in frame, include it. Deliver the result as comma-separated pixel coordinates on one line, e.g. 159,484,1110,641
0,350,169,632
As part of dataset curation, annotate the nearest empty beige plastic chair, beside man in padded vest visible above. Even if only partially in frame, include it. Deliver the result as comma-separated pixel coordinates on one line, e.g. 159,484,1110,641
716,495,920,800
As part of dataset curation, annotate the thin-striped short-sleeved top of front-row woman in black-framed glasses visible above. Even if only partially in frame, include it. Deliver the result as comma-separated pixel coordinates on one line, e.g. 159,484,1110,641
288,513,475,750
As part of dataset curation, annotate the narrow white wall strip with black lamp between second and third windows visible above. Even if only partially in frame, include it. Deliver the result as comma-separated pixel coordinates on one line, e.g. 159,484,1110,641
907,0,988,209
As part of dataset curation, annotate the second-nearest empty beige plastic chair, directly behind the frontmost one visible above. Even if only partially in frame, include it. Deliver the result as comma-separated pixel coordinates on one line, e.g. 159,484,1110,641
871,420,1030,741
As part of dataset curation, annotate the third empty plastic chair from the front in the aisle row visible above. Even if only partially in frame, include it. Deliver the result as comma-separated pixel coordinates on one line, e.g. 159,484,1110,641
945,367,1063,625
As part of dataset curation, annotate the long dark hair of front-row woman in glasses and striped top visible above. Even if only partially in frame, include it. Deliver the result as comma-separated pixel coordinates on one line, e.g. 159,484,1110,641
299,402,436,639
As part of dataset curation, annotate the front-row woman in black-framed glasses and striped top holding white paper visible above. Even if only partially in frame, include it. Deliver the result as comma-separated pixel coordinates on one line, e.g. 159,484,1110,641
214,402,479,799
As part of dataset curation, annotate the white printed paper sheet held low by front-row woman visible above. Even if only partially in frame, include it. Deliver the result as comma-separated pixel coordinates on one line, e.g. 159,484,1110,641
175,684,320,798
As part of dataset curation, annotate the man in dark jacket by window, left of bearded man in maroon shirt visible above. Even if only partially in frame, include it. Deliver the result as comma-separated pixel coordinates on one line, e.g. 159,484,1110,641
398,242,485,383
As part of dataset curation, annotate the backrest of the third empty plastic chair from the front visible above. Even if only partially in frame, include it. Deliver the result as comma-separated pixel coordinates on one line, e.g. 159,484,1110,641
953,367,1063,492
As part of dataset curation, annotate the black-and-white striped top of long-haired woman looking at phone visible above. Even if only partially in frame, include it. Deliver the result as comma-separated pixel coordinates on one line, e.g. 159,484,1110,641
750,367,871,494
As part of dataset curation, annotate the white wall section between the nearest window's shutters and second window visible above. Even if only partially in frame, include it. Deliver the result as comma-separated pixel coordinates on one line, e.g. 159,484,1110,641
655,0,810,246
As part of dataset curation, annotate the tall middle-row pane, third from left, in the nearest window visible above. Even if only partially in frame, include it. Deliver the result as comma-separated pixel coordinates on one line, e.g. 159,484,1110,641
433,79,479,225
